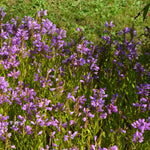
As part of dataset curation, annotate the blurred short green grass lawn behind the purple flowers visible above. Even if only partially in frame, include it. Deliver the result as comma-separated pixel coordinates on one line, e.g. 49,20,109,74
0,0,150,44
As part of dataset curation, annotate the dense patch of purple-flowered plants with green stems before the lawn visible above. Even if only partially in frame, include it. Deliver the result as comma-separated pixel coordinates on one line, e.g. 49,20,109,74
0,2,150,150
